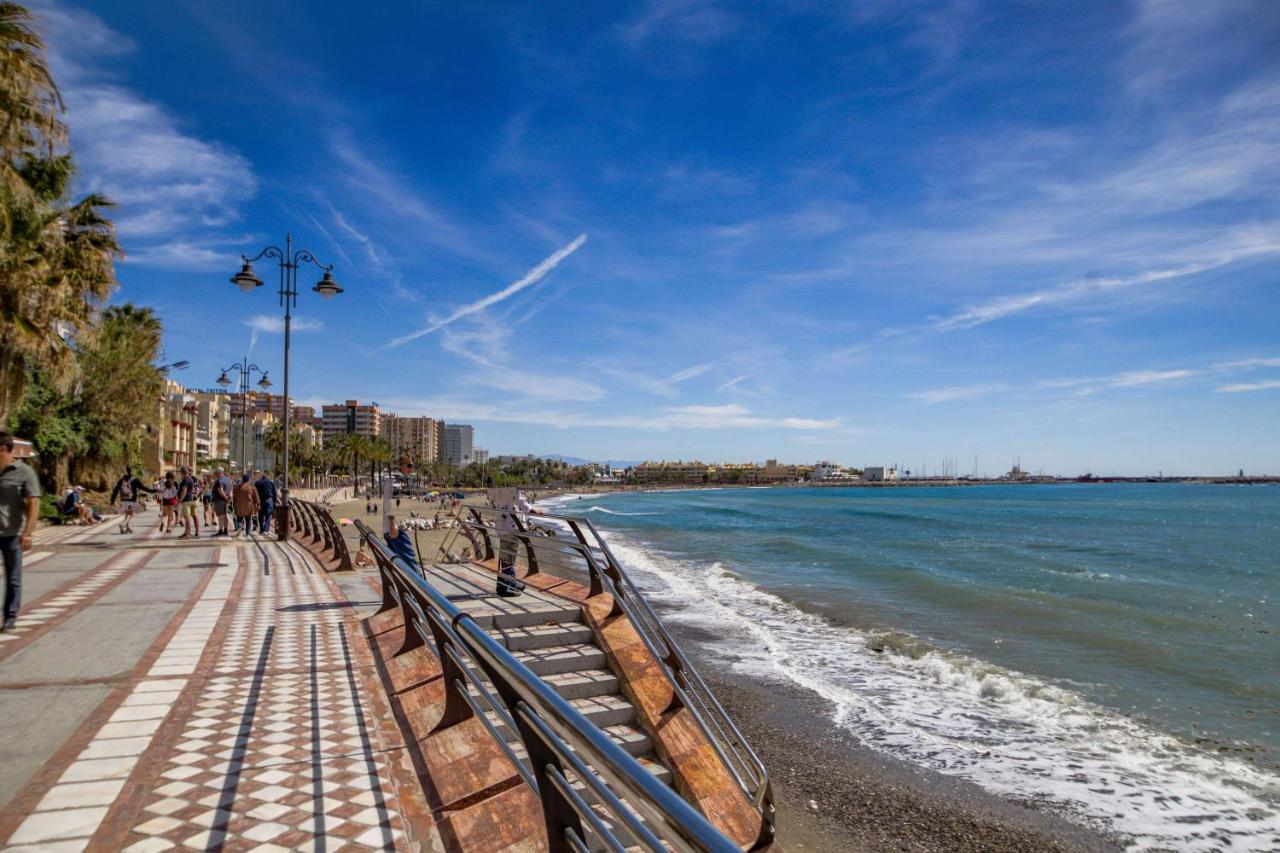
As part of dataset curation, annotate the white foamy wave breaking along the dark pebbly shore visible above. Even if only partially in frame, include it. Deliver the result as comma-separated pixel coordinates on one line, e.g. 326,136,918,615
605,533,1280,850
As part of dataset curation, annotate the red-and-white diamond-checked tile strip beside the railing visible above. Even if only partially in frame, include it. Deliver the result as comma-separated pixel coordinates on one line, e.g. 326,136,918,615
123,543,407,850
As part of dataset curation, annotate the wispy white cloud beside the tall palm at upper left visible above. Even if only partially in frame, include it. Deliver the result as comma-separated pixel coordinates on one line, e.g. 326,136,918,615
36,3,257,269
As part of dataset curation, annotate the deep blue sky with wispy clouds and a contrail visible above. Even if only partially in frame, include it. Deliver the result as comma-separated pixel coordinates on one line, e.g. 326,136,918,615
33,0,1280,474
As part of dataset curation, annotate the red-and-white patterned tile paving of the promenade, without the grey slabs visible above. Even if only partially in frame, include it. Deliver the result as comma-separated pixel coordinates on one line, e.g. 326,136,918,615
0,507,419,850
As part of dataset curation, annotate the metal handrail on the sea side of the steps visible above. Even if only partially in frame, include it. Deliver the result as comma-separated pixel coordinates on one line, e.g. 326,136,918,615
440,506,774,834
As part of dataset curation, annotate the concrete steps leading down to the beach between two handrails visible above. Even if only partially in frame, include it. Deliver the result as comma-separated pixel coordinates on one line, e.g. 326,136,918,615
424,564,672,822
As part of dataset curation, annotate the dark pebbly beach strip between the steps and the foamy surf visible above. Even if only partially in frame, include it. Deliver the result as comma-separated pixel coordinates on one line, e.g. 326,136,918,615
659,611,1123,853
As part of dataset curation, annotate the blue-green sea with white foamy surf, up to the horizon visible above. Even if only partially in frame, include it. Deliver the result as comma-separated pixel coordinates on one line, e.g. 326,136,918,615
541,483,1280,850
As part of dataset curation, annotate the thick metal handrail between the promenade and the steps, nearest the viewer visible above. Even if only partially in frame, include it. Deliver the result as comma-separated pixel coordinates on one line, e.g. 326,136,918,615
356,520,739,853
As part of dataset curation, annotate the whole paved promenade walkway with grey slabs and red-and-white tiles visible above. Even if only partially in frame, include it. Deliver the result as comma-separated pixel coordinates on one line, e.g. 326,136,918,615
0,512,425,852
